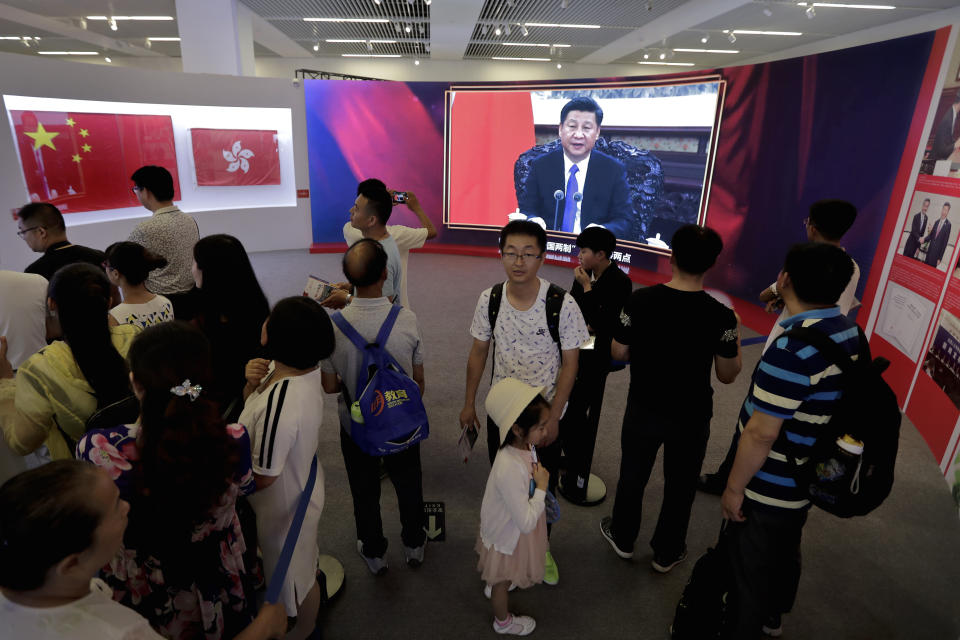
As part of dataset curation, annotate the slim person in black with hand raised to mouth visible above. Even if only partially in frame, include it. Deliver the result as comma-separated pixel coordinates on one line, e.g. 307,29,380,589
560,227,633,504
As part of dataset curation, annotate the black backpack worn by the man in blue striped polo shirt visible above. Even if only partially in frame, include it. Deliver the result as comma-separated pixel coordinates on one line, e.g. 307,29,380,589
783,327,902,518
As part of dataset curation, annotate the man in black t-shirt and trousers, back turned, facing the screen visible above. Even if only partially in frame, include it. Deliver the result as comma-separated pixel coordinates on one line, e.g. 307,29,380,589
600,225,741,573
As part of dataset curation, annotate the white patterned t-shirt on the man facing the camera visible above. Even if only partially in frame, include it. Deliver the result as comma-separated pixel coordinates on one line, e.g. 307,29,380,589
470,278,590,400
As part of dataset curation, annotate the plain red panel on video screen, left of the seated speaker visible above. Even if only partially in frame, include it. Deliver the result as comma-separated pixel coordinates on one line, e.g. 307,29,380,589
450,91,536,227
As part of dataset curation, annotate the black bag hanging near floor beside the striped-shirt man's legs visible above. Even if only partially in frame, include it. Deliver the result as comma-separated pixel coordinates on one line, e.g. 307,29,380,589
670,520,737,640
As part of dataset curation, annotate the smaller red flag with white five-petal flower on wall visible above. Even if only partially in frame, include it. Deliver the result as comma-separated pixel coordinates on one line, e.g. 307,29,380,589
190,129,280,187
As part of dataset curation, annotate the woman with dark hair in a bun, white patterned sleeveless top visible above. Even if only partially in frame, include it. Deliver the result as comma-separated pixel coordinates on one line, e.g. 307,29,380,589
103,242,173,329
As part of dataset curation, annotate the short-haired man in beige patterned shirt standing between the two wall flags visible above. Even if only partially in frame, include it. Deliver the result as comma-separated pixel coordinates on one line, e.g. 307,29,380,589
128,165,200,320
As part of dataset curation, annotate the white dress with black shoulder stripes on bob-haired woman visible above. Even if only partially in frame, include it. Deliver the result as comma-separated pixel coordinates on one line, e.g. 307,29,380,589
239,369,324,615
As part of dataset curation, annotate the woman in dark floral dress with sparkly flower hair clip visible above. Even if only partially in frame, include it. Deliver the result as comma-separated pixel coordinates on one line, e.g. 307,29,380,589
77,321,255,640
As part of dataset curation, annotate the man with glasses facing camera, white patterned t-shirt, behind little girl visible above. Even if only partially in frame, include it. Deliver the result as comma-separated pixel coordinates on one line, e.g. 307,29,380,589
460,220,590,584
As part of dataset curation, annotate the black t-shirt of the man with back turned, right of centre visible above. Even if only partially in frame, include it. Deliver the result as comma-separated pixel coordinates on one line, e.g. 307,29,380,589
614,284,737,422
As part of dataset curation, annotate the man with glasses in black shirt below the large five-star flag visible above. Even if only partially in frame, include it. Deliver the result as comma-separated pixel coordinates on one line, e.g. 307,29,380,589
17,202,104,280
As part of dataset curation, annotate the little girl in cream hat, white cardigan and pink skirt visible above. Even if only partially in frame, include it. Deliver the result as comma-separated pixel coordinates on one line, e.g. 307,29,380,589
476,378,550,636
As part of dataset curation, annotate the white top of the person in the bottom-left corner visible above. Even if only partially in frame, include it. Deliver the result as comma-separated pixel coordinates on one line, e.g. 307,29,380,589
0,578,163,640
